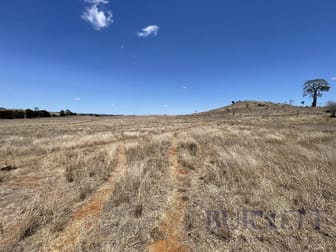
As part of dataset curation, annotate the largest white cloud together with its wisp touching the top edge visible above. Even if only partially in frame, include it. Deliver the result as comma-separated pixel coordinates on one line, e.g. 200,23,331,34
81,0,113,31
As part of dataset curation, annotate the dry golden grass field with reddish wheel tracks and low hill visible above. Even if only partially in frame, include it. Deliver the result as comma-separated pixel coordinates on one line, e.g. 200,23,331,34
0,102,336,252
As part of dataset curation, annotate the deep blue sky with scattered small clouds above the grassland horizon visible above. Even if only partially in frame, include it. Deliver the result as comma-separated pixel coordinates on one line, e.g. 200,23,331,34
0,0,336,114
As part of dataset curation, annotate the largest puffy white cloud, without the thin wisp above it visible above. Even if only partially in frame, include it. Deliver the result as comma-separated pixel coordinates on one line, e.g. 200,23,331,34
82,5,113,31
